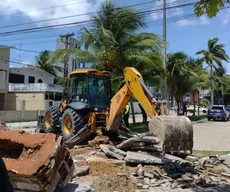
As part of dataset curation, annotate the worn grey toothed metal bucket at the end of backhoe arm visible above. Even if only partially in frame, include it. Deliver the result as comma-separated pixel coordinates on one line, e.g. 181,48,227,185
149,116,193,155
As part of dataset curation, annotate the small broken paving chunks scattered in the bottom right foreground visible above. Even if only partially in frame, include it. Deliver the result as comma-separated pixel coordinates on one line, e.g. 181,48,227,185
92,156,230,192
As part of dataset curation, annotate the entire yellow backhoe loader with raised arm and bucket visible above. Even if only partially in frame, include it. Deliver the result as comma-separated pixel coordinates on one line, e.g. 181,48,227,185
36,67,193,154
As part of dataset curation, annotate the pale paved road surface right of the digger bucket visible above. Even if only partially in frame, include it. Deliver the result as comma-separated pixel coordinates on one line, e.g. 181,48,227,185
193,121,230,151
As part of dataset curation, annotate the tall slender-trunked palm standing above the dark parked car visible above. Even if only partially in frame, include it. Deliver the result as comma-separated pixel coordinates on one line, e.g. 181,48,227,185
196,38,229,105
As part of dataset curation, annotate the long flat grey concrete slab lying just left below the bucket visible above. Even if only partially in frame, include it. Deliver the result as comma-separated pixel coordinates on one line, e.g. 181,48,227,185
125,151,172,164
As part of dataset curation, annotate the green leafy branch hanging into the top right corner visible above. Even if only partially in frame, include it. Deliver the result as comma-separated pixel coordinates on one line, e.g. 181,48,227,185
195,0,230,18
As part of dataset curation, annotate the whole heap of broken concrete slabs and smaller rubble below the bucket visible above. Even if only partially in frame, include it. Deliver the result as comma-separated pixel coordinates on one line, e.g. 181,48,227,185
87,136,230,192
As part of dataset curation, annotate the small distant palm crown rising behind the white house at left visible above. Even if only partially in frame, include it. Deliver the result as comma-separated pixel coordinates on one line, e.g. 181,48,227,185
35,50,60,76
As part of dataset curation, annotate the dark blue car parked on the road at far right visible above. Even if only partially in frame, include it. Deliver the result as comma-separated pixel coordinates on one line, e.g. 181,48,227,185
208,105,229,121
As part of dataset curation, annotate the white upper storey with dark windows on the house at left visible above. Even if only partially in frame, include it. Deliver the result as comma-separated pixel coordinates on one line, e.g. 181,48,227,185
9,65,54,84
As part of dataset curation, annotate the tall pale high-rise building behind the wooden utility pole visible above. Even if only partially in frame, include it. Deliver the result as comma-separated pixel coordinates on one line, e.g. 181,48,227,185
56,37,80,77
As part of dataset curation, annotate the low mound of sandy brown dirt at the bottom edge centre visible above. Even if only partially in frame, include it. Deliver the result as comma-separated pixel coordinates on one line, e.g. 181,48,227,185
93,173,135,192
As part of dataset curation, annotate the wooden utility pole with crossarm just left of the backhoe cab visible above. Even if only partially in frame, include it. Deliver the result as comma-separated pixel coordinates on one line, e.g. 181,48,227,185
60,33,75,99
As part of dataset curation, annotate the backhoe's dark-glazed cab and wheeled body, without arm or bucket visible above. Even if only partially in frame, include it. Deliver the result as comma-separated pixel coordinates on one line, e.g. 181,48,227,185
37,69,112,140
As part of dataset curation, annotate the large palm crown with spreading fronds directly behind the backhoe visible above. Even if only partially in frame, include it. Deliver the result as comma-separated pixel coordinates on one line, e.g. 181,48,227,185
51,0,162,76
